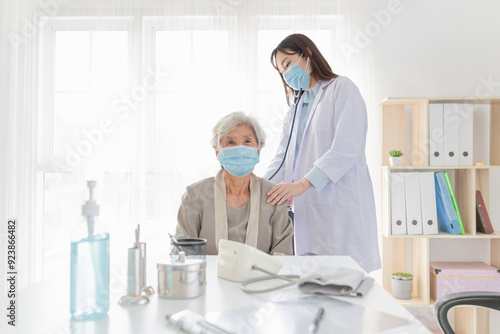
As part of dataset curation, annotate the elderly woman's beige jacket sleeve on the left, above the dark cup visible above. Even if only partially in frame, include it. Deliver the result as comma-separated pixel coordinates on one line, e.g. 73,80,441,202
175,187,201,239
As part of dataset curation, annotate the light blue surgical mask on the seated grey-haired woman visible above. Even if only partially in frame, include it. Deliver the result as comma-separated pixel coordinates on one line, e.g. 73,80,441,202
219,145,259,177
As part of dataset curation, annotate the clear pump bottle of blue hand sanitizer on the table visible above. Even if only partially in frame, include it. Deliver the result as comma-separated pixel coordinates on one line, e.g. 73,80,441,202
70,181,109,320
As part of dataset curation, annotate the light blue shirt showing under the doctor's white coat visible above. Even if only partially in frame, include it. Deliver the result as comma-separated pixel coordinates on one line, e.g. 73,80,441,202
294,81,330,191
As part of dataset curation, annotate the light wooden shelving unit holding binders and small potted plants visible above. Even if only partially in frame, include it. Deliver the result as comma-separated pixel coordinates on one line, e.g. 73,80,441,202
381,97,500,333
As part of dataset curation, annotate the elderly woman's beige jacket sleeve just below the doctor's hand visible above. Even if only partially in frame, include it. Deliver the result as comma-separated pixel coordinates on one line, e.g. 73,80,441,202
270,204,293,255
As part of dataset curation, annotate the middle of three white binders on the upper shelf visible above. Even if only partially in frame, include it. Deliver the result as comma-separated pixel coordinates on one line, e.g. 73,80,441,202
443,103,460,166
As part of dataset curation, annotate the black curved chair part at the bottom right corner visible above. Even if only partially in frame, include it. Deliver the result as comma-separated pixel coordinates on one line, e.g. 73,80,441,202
434,291,500,334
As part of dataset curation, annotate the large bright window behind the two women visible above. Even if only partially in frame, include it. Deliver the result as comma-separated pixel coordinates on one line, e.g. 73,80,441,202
36,16,336,276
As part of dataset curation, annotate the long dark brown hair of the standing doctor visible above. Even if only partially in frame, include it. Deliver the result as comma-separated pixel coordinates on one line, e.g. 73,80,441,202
271,34,338,106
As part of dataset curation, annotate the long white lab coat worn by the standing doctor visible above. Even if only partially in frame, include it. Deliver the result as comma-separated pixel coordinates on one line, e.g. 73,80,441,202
264,76,380,272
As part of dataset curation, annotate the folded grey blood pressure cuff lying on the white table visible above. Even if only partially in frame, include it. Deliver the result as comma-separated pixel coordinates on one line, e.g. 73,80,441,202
298,267,374,297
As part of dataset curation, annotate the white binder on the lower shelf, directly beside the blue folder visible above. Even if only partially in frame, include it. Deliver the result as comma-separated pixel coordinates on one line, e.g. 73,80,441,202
420,172,438,234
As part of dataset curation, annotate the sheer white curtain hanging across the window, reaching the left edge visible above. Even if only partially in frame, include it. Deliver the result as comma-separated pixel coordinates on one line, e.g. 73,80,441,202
0,0,378,291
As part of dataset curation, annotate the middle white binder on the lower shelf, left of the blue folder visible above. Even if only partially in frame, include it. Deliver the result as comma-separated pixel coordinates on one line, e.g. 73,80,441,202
405,172,422,234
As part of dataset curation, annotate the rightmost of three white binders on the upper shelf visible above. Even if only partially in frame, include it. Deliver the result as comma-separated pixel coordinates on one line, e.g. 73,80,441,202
458,103,474,166
